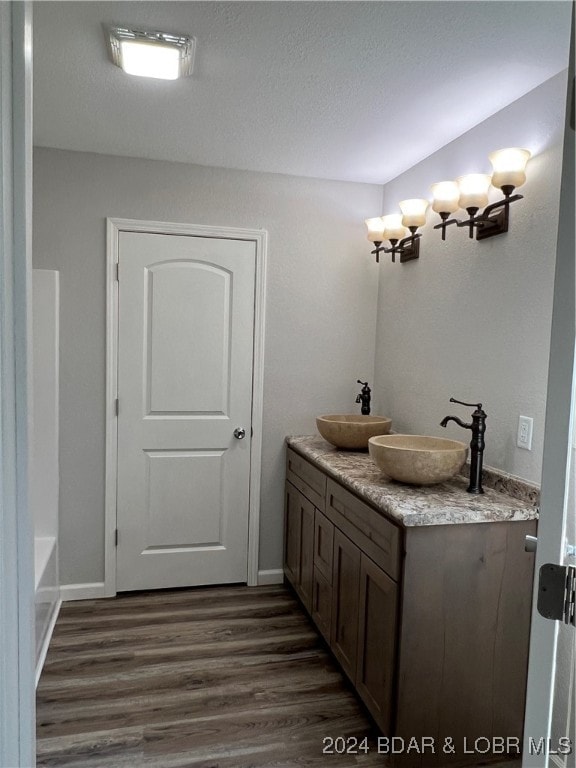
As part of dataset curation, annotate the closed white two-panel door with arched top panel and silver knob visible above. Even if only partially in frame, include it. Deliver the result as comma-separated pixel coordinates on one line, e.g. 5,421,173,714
117,232,256,591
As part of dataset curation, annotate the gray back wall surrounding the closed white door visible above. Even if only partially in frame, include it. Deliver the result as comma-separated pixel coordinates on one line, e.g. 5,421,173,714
34,148,382,584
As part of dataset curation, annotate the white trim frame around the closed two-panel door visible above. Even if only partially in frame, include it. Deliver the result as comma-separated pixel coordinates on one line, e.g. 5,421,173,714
104,218,267,597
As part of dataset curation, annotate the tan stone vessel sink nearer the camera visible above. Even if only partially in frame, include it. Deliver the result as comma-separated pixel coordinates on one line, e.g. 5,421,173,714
368,435,468,485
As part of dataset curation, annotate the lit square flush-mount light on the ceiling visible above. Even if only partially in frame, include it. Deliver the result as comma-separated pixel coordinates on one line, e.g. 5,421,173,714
108,27,196,80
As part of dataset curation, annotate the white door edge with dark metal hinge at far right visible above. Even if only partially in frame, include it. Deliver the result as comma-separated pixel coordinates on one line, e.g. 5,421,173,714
522,40,576,768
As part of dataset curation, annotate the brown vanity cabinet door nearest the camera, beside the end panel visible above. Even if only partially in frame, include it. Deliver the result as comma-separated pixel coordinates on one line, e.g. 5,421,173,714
356,554,398,734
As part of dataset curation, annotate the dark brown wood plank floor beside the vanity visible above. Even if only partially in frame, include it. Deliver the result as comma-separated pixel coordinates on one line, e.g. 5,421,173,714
37,586,519,768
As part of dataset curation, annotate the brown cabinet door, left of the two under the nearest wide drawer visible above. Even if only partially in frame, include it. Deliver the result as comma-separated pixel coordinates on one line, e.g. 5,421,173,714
330,528,360,682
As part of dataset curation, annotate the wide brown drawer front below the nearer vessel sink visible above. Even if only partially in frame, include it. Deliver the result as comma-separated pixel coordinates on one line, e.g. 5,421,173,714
325,479,401,580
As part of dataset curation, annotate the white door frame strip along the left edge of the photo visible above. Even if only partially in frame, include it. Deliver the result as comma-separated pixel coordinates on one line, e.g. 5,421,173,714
0,2,36,768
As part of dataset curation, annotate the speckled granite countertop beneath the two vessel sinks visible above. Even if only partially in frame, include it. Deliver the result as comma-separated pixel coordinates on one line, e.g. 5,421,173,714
286,435,539,527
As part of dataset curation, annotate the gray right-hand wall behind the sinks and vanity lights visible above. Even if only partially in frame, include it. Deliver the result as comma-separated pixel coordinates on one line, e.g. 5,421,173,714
374,73,566,482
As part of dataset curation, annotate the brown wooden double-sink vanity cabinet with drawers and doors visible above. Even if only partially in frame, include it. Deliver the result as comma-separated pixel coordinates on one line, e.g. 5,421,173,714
284,439,536,768
